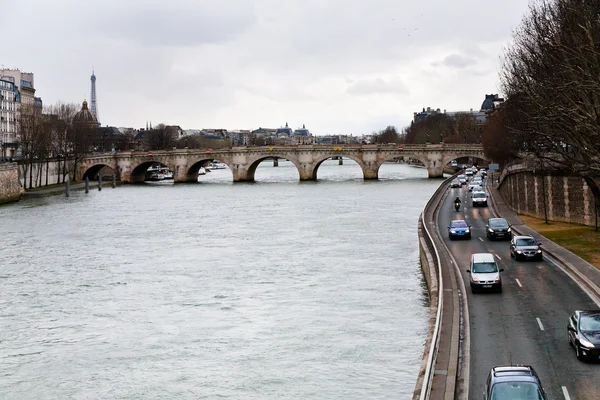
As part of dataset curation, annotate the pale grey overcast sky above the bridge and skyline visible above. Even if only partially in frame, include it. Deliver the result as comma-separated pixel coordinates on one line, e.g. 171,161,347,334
0,0,527,135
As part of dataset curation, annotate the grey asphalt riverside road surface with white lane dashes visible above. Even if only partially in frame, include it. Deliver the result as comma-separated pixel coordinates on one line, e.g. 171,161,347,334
437,182,600,400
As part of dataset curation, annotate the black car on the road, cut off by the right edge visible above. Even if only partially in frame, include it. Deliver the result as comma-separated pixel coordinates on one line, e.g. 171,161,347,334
567,310,600,360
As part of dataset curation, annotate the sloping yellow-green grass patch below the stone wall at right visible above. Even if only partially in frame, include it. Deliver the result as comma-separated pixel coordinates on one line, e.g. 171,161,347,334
519,214,600,269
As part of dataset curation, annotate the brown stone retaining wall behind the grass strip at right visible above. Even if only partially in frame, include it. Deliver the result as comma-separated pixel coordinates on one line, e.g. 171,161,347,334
498,170,600,226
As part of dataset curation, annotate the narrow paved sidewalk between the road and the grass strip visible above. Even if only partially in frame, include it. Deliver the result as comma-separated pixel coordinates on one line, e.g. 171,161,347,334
487,184,600,296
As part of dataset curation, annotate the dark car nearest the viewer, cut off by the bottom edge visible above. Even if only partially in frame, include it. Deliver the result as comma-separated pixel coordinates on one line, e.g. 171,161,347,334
483,365,548,400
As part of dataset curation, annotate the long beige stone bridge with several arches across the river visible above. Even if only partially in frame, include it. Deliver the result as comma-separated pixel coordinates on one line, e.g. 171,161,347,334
77,144,487,183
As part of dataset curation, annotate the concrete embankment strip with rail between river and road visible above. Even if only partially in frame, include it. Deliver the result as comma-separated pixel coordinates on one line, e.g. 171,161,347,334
413,176,468,400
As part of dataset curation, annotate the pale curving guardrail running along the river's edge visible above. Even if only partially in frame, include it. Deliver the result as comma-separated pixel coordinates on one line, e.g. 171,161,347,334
419,172,460,400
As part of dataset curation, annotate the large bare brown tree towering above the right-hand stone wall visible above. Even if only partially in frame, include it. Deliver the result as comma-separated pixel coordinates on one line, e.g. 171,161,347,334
501,0,600,222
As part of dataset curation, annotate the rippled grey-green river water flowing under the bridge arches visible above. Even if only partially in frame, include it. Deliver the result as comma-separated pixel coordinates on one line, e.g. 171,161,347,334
0,160,440,400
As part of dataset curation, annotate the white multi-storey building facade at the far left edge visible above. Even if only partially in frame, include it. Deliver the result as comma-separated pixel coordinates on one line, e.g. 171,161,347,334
0,79,21,161
